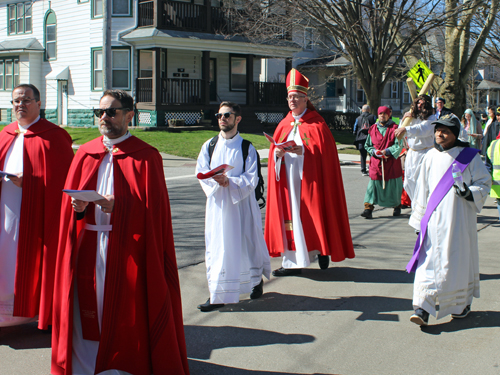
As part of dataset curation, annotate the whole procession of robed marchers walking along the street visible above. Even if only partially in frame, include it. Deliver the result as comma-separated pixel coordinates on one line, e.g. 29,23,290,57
0,69,500,375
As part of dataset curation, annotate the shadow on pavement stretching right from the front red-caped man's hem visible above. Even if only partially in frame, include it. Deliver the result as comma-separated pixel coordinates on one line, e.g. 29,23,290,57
184,325,315,359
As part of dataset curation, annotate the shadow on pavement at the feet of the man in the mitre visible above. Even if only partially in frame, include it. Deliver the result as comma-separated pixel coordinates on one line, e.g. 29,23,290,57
297,263,414,284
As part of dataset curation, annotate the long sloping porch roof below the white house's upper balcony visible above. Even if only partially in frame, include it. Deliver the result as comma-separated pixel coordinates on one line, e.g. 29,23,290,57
122,27,301,58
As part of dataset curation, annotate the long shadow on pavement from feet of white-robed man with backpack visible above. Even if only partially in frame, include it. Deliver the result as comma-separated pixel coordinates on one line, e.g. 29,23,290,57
219,293,412,322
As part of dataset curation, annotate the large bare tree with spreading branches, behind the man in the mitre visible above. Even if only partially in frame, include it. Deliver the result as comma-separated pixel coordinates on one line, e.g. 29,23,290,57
232,0,444,111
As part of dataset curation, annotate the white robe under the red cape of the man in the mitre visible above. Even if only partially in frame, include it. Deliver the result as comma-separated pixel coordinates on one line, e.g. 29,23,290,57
274,109,320,268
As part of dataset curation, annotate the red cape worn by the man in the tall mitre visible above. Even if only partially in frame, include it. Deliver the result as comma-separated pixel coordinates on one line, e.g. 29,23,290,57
265,110,354,262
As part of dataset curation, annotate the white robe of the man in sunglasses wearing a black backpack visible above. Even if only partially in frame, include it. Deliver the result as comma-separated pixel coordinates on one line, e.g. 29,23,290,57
196,134,271,304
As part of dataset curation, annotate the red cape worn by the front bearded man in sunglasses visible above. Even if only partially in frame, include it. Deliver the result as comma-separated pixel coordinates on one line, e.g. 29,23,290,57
52,136,189,375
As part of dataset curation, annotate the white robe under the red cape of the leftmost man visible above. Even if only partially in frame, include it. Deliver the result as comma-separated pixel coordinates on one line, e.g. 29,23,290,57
0,117,40,327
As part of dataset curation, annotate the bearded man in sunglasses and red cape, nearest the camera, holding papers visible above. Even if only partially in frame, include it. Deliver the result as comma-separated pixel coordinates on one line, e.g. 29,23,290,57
52,90,189,375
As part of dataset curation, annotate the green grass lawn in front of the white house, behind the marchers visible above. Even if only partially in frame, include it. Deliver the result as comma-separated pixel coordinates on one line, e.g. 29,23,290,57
0,127,357,159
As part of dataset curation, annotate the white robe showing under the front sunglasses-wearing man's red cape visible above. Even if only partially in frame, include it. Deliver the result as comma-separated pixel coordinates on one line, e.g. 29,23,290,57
72,132,130,375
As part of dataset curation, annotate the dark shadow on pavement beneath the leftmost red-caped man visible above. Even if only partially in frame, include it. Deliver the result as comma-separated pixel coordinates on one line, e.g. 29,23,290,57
0,322,51,350
